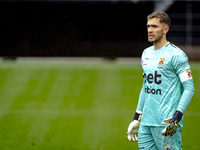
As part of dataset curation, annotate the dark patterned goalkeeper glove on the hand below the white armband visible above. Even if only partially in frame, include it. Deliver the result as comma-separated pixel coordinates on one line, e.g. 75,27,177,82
162,110,183,137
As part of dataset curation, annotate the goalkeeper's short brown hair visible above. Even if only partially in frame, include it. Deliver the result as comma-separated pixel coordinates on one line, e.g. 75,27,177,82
147,11,171,26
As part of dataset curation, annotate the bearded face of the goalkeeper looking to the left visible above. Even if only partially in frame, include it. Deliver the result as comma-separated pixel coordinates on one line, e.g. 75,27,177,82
147,18,165,43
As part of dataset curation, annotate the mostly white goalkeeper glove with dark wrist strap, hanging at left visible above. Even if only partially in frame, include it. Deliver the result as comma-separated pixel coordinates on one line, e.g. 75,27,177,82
127,112,142,142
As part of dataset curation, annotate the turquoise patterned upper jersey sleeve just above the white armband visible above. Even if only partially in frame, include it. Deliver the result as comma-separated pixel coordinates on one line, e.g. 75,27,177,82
172,50,190,74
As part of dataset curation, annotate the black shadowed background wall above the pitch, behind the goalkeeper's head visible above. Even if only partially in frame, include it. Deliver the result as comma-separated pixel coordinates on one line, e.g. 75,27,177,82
0,1,200,57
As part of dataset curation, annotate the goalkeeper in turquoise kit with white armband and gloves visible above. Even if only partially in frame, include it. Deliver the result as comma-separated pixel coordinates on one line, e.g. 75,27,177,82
127,11,194,150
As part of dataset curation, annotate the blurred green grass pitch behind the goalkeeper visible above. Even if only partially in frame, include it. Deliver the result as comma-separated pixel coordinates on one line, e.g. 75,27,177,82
0,59,200,150
